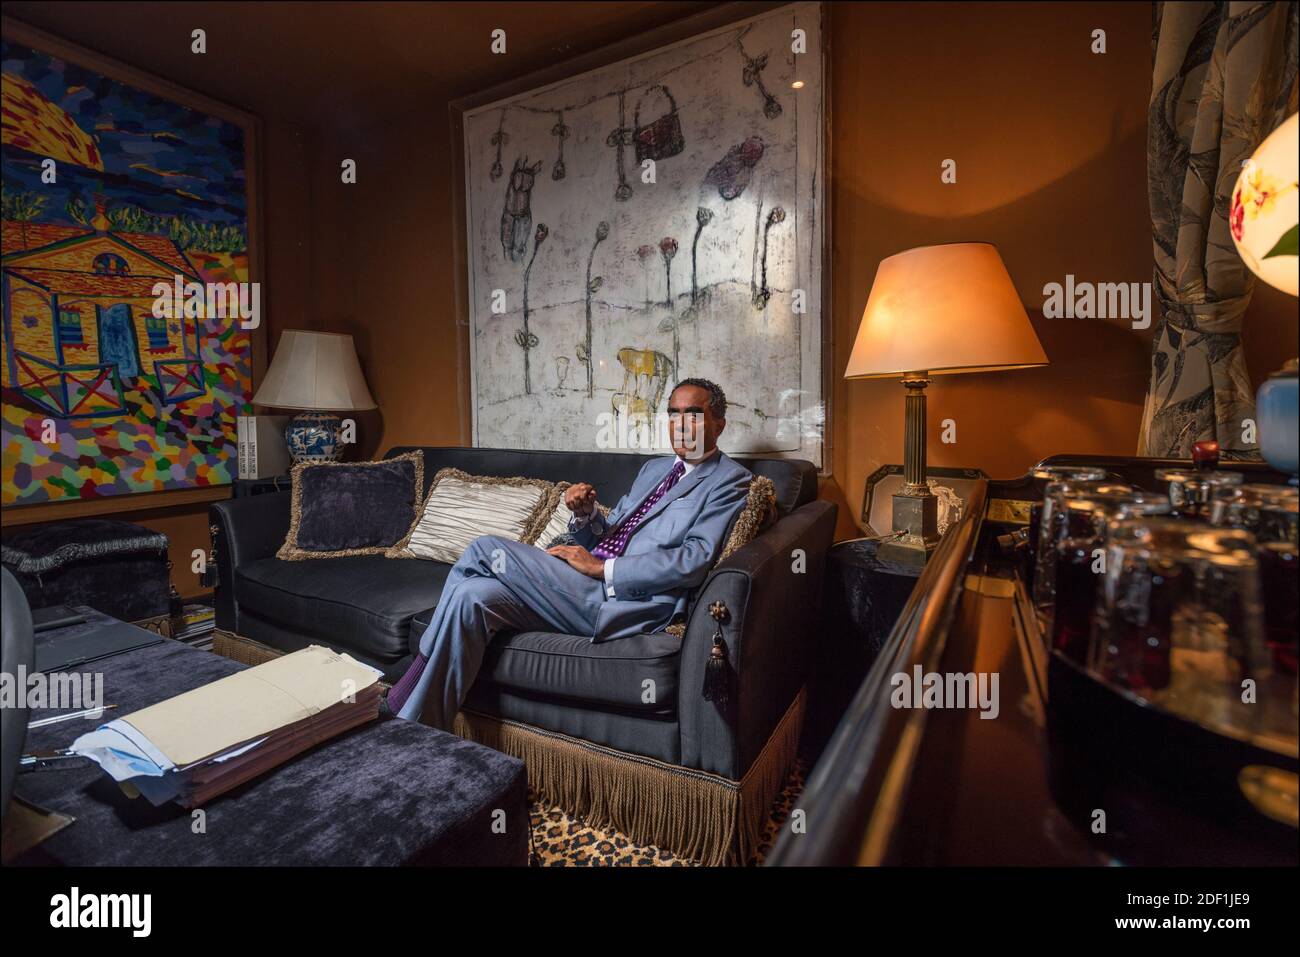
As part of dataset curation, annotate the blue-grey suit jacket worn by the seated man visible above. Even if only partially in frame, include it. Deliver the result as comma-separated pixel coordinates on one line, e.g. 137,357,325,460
569,450,754,641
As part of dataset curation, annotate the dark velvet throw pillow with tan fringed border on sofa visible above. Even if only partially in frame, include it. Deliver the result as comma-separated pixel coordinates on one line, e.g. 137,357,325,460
276,452,424,562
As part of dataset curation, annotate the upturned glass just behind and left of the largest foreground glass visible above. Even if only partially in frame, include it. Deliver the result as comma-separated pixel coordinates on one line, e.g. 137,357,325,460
1040,482,1169,664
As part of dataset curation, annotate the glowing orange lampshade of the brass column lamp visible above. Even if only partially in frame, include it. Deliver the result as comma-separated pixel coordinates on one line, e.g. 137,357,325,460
844,243,1048,378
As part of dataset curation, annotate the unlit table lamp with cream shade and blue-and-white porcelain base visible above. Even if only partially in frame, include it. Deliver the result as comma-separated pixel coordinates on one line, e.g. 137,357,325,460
252,329,376,463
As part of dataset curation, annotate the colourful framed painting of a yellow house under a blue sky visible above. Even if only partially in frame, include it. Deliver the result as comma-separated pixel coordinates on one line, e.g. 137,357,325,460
0,21,260,506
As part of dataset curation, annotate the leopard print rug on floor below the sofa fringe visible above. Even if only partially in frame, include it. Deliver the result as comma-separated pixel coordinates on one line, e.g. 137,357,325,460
528,758,805,867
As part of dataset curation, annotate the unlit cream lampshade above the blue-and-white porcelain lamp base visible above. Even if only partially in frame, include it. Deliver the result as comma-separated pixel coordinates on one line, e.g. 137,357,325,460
252,329,374,412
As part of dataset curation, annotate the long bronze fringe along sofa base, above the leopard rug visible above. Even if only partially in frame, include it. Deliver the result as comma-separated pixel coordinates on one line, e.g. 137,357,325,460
452,688,805,866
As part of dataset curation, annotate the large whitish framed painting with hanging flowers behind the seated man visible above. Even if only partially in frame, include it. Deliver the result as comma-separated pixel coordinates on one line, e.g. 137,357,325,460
463,3,827,467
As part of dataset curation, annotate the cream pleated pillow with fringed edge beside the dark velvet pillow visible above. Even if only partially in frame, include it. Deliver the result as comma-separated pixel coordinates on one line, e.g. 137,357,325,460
385,468,560,564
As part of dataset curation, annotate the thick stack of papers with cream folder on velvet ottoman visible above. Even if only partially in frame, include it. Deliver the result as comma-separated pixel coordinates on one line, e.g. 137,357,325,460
69,645,381,807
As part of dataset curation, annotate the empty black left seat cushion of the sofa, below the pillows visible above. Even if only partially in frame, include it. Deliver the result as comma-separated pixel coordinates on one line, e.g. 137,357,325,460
235,555,451,661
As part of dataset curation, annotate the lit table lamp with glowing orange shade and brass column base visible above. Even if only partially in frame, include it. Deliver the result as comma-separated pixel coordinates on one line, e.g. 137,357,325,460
844,243,1048,564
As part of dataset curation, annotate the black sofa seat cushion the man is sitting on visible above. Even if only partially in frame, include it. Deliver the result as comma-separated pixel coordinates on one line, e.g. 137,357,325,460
411,609,681,714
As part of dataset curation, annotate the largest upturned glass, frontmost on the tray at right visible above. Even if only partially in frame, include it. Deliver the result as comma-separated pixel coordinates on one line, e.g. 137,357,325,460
1087,518,1296,752
